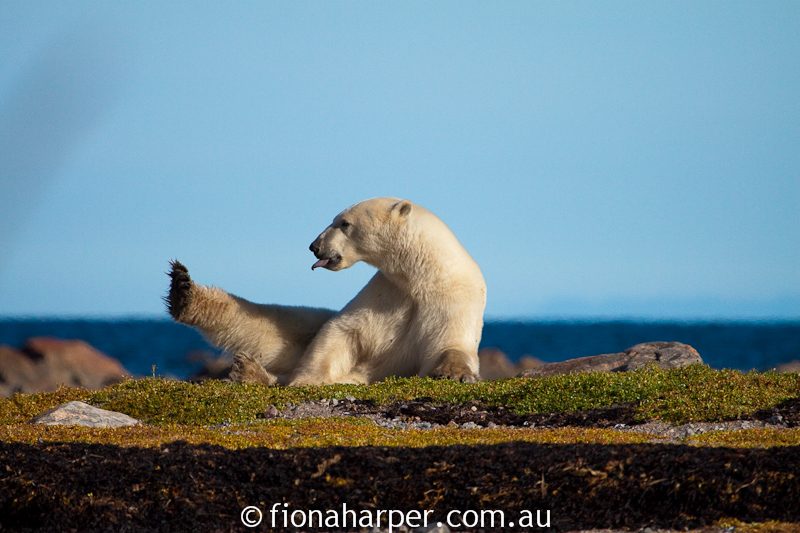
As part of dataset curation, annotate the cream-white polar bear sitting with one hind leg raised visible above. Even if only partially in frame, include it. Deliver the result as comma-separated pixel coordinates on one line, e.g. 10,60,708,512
165,198,486,385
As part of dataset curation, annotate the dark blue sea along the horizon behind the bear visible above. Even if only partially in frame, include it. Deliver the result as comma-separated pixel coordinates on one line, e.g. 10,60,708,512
0,319,800,378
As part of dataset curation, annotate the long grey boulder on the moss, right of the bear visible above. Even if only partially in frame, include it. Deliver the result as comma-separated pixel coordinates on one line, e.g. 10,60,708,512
522,342,703,377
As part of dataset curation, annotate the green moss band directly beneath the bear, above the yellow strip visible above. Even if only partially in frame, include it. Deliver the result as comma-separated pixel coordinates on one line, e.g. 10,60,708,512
0,365,800,425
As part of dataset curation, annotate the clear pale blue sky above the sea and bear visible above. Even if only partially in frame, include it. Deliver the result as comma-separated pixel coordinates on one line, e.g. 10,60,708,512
0,1,800,318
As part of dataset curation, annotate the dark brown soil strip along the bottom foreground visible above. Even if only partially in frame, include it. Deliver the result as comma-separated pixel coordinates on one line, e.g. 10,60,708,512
0,443,800,531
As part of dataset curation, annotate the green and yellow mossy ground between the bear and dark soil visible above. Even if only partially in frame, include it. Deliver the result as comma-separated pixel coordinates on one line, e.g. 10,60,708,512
0,365,800,449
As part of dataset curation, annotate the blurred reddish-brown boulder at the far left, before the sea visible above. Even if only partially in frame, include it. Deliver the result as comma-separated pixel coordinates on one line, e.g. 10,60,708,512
0,337,129,396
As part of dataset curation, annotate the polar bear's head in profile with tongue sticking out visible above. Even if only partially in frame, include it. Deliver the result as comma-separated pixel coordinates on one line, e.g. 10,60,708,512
309,198,413,271
